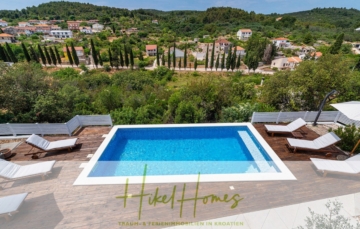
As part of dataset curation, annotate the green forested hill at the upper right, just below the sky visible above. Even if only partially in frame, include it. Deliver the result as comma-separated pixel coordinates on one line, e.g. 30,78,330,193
286,8,360,29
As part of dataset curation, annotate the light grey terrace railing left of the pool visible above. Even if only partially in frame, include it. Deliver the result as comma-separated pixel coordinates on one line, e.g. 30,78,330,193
0,115,113,136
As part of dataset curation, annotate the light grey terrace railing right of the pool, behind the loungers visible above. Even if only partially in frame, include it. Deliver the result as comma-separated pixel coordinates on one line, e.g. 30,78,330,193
251,111,360,127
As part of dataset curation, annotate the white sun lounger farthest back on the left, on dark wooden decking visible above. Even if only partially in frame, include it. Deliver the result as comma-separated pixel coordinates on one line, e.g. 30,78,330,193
25,134,78,158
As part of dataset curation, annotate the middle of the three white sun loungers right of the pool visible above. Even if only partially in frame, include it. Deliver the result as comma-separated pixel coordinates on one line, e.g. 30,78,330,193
286,132,341,152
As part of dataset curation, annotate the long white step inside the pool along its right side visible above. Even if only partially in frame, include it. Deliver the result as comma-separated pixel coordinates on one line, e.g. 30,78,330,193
238,131,276,172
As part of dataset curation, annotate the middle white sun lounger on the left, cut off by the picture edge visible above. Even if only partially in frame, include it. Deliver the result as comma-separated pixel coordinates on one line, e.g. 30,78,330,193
0,159,56,180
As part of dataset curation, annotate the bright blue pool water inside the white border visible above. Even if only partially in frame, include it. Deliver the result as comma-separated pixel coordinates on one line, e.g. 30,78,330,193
89,126,279,177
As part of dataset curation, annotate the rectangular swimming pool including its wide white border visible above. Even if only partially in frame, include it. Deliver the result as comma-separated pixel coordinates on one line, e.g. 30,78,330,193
74,123,295,185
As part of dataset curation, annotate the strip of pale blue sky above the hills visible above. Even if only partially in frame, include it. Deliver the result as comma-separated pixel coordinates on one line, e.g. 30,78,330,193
0,0,360,14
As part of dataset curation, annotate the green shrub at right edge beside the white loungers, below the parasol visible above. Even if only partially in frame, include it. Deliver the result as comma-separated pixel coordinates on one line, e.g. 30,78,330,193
329,124,360,153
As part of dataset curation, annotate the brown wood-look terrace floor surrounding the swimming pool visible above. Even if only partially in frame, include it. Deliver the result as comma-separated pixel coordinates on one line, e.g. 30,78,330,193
0,124,360,228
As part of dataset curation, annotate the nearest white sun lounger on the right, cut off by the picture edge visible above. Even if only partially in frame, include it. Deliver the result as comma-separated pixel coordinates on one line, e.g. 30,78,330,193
310,154,360,177
